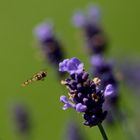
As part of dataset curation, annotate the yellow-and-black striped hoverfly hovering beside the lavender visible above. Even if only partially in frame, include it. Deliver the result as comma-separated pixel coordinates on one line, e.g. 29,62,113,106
21,71,47,87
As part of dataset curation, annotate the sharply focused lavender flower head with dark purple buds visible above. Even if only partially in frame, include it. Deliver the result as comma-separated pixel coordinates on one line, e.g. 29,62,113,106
59,58,111,127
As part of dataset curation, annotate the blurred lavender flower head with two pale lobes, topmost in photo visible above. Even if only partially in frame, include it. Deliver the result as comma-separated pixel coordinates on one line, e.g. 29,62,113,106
73,5,107,54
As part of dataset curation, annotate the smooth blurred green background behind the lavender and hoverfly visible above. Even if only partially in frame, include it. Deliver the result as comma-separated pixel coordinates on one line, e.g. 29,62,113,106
0,0,140,140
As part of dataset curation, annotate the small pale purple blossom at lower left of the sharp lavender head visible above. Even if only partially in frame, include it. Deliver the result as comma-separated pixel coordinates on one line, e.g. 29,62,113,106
60,96,75,110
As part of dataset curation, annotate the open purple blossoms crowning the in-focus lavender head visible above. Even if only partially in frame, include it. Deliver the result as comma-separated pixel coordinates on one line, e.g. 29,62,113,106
59,57,84,74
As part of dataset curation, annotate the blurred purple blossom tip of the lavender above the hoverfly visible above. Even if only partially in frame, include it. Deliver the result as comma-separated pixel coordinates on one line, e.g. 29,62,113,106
34,22,53,41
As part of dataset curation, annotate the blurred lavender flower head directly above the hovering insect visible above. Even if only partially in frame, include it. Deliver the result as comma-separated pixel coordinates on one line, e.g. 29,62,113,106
34,22,64,76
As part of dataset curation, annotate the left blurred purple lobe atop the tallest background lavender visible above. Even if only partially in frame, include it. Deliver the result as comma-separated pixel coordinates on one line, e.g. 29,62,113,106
72,11,86,27
